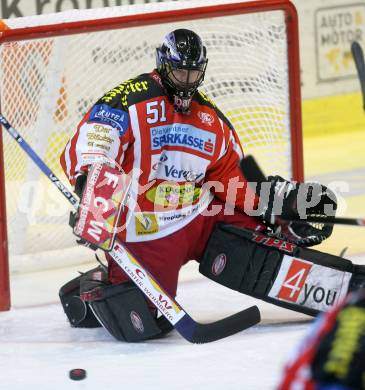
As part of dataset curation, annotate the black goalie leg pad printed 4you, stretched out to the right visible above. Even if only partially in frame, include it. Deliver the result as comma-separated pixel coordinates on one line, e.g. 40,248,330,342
199,224,365,316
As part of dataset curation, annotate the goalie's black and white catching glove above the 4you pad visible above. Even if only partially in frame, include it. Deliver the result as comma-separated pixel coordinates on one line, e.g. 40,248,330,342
262,176,337,246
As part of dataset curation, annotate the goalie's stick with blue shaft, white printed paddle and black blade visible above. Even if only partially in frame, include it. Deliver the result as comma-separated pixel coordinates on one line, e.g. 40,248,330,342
0,114,261,344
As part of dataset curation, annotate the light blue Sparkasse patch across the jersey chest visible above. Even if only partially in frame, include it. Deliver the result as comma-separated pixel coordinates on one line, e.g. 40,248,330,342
150,123,216,156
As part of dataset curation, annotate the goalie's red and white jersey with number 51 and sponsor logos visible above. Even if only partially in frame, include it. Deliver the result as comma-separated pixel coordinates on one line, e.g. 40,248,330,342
61,71,256,242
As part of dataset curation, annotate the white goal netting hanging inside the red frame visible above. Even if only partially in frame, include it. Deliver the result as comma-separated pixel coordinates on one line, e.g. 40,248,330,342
0,2,298,272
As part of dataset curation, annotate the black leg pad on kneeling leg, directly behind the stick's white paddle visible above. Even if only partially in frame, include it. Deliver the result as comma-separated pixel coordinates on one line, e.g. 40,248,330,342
81,282,172,342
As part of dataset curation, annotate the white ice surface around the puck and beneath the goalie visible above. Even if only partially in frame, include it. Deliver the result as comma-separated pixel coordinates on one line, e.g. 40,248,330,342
0,266,308,390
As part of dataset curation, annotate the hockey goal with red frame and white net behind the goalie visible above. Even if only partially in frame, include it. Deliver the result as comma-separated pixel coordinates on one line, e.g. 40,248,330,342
0,0,304,310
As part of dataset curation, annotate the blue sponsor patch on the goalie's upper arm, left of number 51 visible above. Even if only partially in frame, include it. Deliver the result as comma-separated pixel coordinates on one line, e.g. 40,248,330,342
88,104,128,135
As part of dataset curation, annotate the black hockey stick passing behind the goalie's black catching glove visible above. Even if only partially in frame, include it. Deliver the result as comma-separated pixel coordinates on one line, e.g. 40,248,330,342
240,156,365,226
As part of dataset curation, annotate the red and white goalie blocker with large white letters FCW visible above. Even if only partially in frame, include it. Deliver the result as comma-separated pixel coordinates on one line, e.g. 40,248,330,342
70,164,131,251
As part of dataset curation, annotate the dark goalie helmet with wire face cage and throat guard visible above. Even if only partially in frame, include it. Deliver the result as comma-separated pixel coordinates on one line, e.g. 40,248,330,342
156,29,208,114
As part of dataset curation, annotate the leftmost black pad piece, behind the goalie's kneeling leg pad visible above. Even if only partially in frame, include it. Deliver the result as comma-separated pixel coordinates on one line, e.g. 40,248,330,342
59,267,103,328
